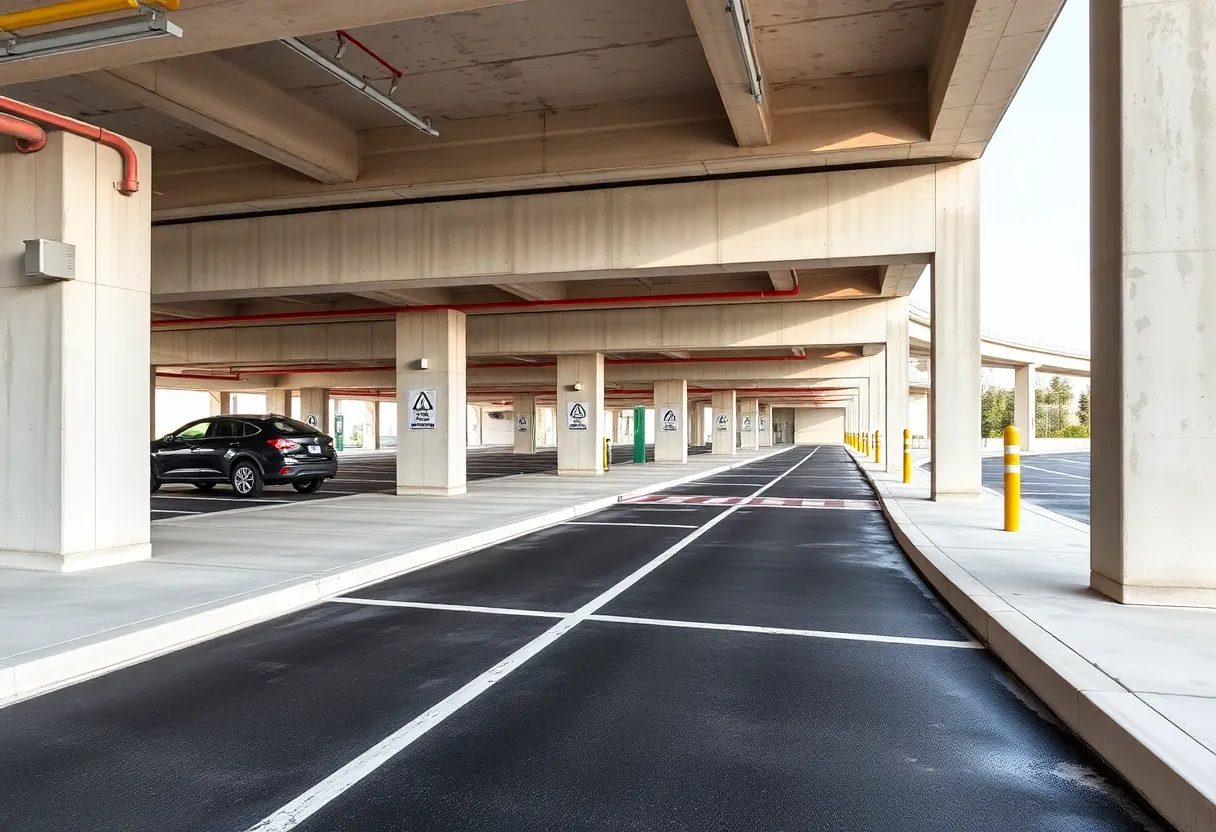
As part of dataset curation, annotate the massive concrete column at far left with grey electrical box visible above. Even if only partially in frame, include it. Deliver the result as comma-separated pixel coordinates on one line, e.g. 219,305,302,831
0,133,152,572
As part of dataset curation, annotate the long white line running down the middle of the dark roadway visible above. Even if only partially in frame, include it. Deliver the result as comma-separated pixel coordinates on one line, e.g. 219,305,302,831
240,448,818,832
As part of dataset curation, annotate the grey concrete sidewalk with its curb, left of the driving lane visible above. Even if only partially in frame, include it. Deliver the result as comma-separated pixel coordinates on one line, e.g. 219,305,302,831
0,448,787,705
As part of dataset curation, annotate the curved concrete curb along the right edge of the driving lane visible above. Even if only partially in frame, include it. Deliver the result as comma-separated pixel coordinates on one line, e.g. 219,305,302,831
857,463,1216,832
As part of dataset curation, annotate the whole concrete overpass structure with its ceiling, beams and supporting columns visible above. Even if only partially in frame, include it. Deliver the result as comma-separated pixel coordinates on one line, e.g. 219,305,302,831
0,0,1216,601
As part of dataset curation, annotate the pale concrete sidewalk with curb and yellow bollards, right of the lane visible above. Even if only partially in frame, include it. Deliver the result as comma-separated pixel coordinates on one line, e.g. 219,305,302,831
861,462,1216,832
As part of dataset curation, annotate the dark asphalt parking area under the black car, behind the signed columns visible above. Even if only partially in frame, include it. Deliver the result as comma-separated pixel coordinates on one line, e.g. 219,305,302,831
152,445,709,521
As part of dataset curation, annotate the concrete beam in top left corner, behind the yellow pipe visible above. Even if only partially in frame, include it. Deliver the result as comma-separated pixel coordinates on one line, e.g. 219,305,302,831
0,0,532,86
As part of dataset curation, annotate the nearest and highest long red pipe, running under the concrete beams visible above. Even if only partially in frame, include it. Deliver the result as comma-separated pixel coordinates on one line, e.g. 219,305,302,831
152,286,799,328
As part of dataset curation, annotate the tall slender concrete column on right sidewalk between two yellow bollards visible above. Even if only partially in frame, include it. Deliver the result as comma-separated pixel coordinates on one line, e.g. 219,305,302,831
929,162,980,500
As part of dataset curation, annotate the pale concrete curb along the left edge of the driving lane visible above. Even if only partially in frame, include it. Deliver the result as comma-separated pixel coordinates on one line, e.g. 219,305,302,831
0,448,788,708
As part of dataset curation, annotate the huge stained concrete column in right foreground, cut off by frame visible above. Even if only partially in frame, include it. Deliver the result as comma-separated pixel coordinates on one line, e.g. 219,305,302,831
1090,0,1216,607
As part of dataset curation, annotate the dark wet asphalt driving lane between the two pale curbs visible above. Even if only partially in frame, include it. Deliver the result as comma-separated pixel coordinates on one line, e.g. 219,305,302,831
0,446,1160,832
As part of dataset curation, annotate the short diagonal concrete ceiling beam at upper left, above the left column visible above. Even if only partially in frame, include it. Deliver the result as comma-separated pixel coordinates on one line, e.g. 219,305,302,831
88,55,359,185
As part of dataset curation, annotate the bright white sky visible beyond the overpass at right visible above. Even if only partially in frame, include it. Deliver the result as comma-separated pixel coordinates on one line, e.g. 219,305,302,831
912,0,1090,352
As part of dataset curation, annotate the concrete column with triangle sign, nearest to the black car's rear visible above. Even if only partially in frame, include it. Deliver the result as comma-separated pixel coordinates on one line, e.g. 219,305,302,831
396,309,468,496
